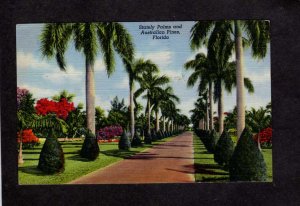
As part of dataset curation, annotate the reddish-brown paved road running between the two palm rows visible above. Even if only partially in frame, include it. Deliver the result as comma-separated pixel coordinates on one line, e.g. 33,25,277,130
70,132,195,184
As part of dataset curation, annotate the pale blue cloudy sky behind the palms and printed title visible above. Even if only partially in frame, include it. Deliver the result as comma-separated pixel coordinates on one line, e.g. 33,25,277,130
16,21,271,116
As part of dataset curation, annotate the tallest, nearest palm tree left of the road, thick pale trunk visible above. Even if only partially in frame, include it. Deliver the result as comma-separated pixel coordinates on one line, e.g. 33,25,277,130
41,22,134,133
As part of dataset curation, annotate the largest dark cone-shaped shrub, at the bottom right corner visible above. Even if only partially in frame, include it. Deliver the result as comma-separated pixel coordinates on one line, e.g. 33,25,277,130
229,128,267,181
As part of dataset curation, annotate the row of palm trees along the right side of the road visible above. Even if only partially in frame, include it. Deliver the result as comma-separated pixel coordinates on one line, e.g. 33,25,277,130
185,20,270,138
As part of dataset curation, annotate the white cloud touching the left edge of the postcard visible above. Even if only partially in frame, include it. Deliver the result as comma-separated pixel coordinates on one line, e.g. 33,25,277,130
17,52,50,70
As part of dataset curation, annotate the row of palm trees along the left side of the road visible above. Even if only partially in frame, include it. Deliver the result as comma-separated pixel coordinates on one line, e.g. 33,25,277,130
41,22,185,141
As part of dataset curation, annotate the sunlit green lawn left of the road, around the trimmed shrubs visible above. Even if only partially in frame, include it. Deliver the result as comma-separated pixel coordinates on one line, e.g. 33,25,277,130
18,137,172,185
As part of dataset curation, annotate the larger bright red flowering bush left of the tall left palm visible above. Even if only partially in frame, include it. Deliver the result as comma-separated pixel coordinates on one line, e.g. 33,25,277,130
35,98,75,119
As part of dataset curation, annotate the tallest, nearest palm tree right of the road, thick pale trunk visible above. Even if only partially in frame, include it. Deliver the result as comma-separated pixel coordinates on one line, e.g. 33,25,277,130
191,20,270,138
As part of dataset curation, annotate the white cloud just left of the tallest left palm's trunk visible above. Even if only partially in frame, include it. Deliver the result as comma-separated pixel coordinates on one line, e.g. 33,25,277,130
42,66,84,84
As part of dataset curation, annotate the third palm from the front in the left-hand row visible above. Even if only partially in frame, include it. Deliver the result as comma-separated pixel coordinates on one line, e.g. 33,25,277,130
136,63,170,134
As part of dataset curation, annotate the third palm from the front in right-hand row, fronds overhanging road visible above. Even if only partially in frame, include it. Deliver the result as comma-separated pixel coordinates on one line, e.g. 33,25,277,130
184,53,214,129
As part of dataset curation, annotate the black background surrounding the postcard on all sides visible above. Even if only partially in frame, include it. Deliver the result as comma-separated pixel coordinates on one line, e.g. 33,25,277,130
0,0,300,205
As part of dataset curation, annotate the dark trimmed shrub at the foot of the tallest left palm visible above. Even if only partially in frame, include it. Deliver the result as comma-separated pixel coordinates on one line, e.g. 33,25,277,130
80,131,100,160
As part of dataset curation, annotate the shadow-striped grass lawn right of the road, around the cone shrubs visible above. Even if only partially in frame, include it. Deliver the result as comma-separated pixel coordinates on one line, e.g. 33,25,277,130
193,135,272,182
